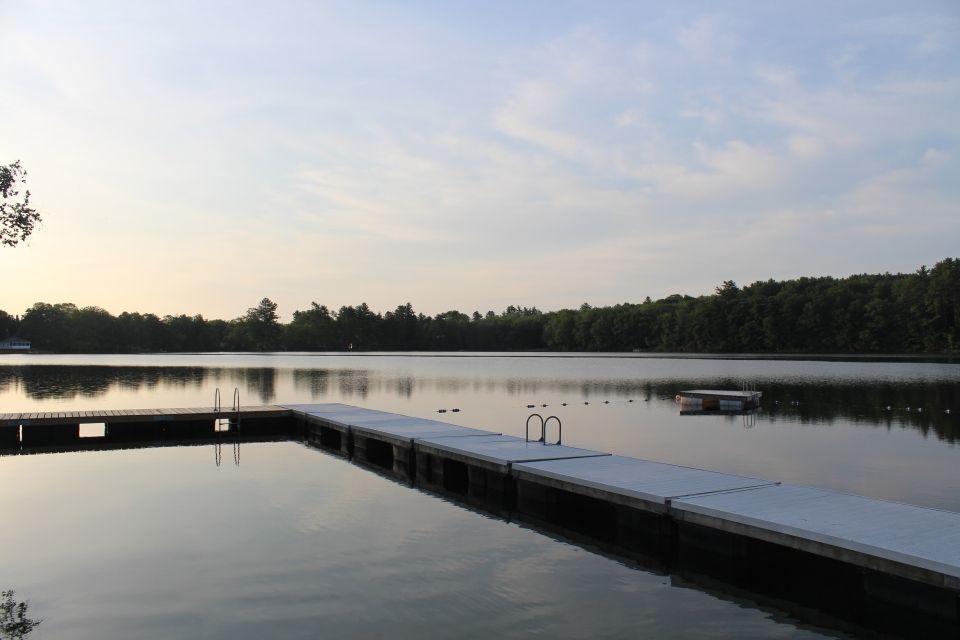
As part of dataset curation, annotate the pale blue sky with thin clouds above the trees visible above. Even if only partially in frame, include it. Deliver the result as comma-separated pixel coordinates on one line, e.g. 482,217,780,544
0,0,960,321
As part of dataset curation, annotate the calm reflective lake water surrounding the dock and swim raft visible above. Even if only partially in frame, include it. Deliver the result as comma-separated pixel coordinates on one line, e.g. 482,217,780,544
0,353,960,638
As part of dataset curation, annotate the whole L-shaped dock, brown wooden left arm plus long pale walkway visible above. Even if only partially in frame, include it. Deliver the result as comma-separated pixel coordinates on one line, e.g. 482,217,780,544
0,402,960,637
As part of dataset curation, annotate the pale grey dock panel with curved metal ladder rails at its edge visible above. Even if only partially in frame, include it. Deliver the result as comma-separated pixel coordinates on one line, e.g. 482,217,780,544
417,436,610,470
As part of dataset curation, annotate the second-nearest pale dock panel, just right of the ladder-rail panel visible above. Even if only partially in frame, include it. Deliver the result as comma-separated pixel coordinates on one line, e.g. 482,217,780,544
513,456,776,505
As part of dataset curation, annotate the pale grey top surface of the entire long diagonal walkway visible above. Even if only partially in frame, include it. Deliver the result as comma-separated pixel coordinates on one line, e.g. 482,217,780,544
283,402,960,589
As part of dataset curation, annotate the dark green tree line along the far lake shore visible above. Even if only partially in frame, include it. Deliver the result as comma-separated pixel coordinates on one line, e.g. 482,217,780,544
0,258,960,353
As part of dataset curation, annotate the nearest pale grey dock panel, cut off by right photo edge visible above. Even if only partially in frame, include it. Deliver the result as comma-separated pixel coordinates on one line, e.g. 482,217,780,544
672,485,960,588
